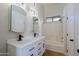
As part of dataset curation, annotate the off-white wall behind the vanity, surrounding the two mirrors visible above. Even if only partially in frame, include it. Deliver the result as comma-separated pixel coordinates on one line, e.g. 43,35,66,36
0,3,42,55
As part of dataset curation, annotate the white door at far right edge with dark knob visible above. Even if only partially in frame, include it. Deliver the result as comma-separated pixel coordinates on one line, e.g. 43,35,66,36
74,4,79,56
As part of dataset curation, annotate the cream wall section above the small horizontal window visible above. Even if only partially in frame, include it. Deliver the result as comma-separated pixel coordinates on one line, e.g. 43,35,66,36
44,3,65,17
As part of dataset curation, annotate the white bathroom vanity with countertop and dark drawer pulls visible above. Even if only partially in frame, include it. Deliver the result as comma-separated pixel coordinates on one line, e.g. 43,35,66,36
7,36,45,56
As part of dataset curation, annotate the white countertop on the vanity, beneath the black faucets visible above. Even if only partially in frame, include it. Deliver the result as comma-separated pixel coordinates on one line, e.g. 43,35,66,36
7,36,44,48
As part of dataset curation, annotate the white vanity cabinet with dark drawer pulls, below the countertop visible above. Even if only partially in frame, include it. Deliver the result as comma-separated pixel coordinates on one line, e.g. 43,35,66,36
8,36,45,56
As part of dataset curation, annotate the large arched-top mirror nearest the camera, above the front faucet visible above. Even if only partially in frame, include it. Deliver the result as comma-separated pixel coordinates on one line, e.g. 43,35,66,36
10,5,26,32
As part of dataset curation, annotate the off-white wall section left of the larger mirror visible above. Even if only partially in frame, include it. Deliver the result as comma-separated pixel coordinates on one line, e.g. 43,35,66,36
0,3,17,53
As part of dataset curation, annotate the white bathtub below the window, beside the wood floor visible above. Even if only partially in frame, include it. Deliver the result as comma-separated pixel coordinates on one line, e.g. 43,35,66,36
45,41,64,53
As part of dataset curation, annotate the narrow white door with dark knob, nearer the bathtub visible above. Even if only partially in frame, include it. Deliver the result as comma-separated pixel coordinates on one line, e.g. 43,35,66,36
67,4,74,56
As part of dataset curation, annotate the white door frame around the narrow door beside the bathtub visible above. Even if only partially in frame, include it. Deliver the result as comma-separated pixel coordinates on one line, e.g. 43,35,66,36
63,4,75,55
